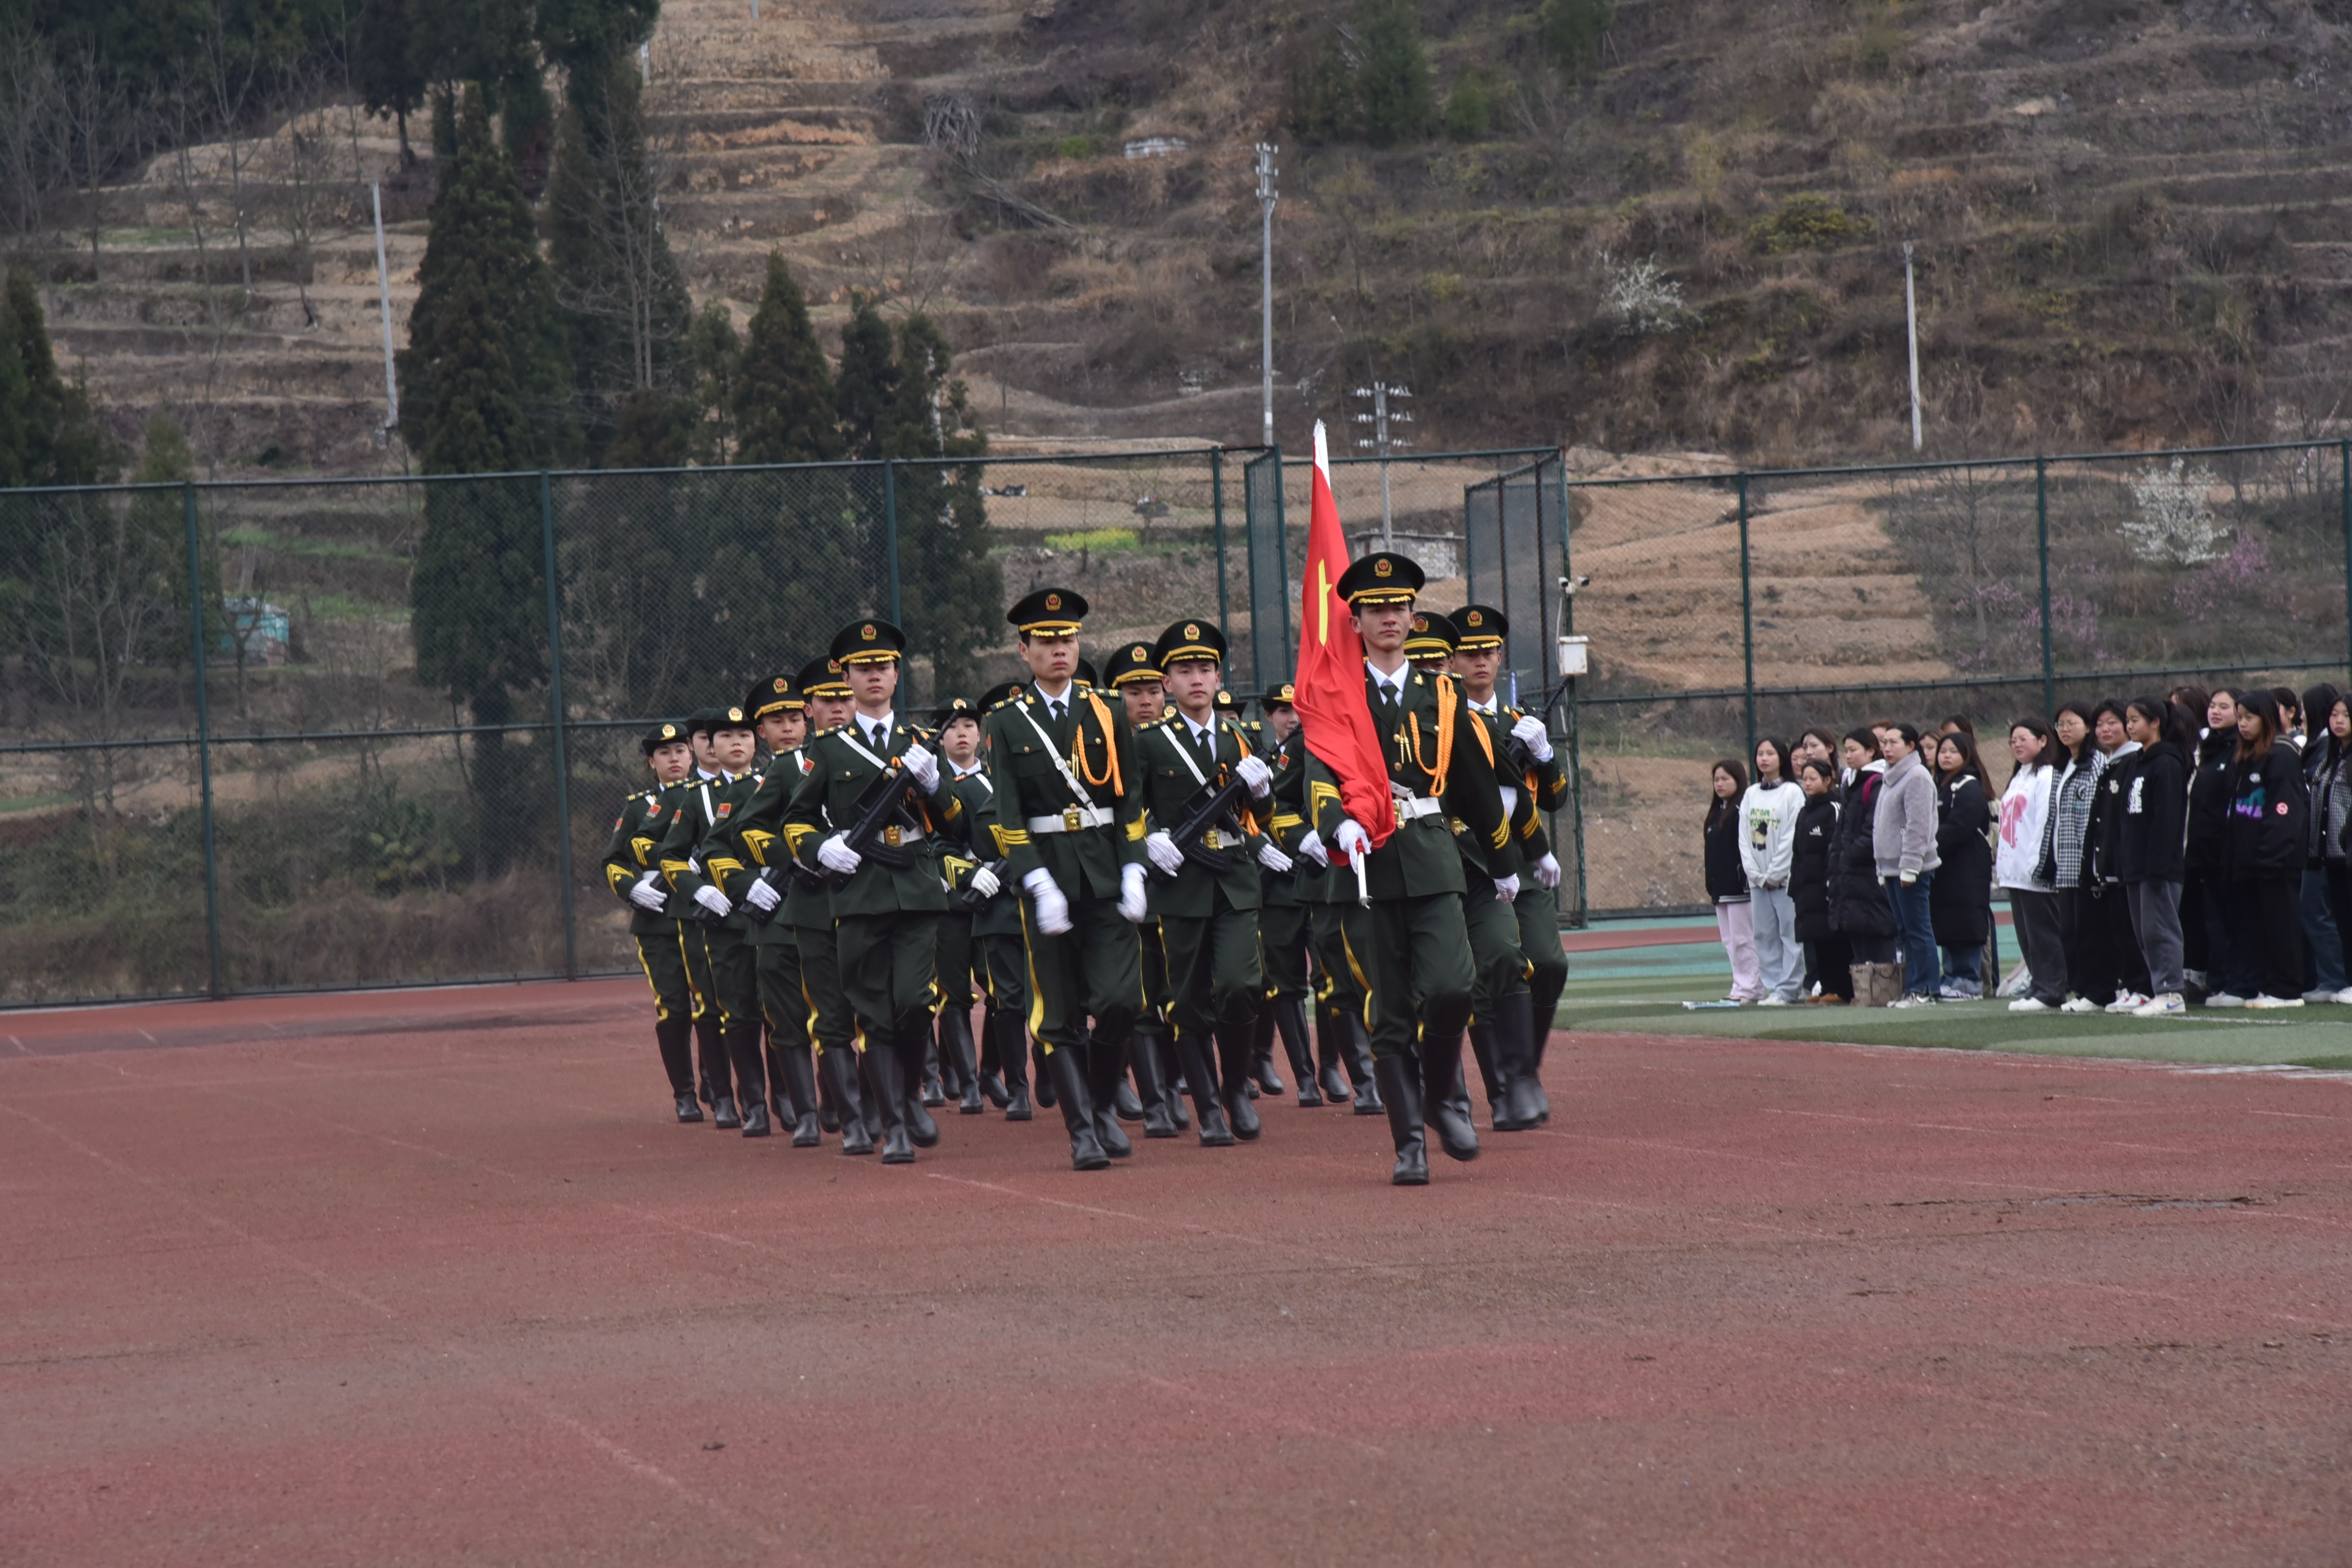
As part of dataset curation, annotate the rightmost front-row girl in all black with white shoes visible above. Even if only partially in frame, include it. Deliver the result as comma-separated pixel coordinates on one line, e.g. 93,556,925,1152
2220,691,2310,1009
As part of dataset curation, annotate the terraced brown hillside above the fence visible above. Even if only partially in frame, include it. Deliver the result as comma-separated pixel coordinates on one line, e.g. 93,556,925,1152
14,0,2352,472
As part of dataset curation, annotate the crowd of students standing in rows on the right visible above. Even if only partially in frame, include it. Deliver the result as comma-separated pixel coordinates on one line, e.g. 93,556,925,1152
1705,684,2352,1018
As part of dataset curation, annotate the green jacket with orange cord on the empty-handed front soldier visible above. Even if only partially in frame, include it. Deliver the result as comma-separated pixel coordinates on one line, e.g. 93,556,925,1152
981,682,1145,900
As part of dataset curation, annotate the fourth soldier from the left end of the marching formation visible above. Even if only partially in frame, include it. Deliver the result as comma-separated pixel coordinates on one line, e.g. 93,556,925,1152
720,675,823,1149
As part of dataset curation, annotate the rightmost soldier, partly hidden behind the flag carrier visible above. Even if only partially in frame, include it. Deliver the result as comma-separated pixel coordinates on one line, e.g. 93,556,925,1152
1453,604,1569,1131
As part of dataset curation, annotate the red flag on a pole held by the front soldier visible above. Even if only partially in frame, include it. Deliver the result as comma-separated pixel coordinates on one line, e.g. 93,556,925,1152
1298,419,1397,849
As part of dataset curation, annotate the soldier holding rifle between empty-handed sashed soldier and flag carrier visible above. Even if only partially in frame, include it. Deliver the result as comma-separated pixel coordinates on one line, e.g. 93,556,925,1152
1136,621,1291,1147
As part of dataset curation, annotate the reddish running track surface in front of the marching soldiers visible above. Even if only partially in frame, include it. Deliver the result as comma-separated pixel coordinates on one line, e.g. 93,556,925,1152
0,985,2352,1568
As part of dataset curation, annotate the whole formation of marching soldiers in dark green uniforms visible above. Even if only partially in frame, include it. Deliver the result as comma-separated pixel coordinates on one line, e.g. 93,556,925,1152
605,553,1569,1185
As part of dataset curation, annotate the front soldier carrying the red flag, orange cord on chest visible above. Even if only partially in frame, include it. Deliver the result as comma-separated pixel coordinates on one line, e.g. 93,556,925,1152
1308,553,1520,1187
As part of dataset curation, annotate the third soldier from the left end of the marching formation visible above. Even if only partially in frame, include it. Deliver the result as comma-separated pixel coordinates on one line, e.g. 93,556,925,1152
654,707,771,1138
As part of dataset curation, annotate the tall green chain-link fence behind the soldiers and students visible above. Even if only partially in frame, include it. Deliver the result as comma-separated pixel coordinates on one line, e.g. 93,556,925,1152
0,444,2352,1004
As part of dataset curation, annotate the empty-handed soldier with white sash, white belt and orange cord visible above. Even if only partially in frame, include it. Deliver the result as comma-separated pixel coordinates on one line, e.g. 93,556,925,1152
981,587,1150,1171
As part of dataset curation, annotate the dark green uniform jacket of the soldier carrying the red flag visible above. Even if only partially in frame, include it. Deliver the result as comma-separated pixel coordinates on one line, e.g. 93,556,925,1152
1308,670,1520,898
